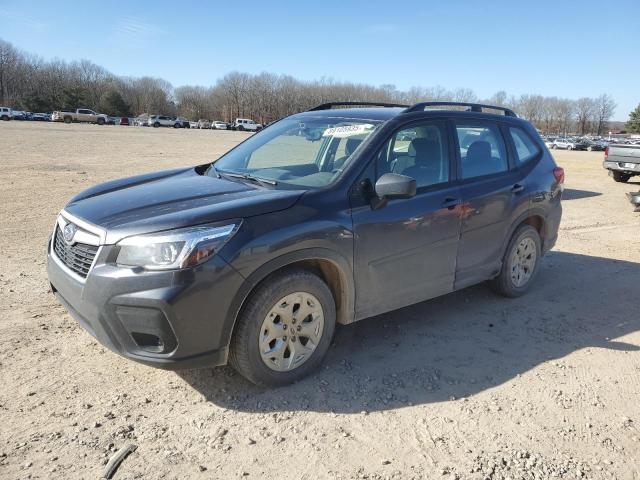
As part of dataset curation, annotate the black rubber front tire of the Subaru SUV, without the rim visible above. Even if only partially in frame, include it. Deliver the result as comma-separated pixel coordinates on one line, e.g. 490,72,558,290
229,269,336,387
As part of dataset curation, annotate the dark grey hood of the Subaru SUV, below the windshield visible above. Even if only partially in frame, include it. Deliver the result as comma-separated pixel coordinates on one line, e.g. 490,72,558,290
64,167,303,244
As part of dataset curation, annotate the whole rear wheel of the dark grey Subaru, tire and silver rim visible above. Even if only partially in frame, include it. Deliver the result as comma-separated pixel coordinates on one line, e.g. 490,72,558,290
490,225,542,297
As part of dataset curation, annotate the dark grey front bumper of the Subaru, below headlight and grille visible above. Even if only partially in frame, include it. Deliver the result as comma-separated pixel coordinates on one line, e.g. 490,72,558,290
47,245,244,370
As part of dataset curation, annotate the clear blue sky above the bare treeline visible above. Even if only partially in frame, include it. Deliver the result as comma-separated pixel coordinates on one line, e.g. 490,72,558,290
0,0,640,120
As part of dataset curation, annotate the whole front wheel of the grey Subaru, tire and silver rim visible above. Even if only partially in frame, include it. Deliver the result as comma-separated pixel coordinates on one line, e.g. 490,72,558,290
229,270,336,386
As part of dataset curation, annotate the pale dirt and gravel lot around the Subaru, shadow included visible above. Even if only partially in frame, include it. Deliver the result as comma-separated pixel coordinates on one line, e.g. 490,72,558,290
0,121,640,479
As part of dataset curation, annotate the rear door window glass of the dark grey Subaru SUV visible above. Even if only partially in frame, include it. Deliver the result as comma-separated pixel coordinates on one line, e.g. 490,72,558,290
456,122,509,179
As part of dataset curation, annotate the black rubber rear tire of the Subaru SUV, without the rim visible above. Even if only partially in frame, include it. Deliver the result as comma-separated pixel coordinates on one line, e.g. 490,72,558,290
489,225,542,298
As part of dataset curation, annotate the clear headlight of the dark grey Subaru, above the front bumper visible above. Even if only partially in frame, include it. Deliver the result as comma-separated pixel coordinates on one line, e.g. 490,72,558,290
116,224,239,270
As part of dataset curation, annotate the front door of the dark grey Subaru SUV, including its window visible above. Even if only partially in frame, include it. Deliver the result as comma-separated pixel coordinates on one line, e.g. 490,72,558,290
352,120,461,318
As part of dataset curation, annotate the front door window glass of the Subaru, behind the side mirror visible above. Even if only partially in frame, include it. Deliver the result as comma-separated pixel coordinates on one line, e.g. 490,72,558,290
376,121,449,188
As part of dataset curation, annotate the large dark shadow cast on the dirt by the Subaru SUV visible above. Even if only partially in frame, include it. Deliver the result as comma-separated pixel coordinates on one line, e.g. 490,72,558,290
179,252,640,413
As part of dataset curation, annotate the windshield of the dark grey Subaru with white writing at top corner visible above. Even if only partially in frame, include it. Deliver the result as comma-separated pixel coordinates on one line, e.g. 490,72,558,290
209,117,380,188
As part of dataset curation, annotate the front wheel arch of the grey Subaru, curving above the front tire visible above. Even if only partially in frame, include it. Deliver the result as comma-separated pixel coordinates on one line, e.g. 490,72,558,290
223,248,355,356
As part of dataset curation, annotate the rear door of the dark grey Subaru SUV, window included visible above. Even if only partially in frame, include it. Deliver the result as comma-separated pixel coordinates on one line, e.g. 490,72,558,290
454,119,528,289
